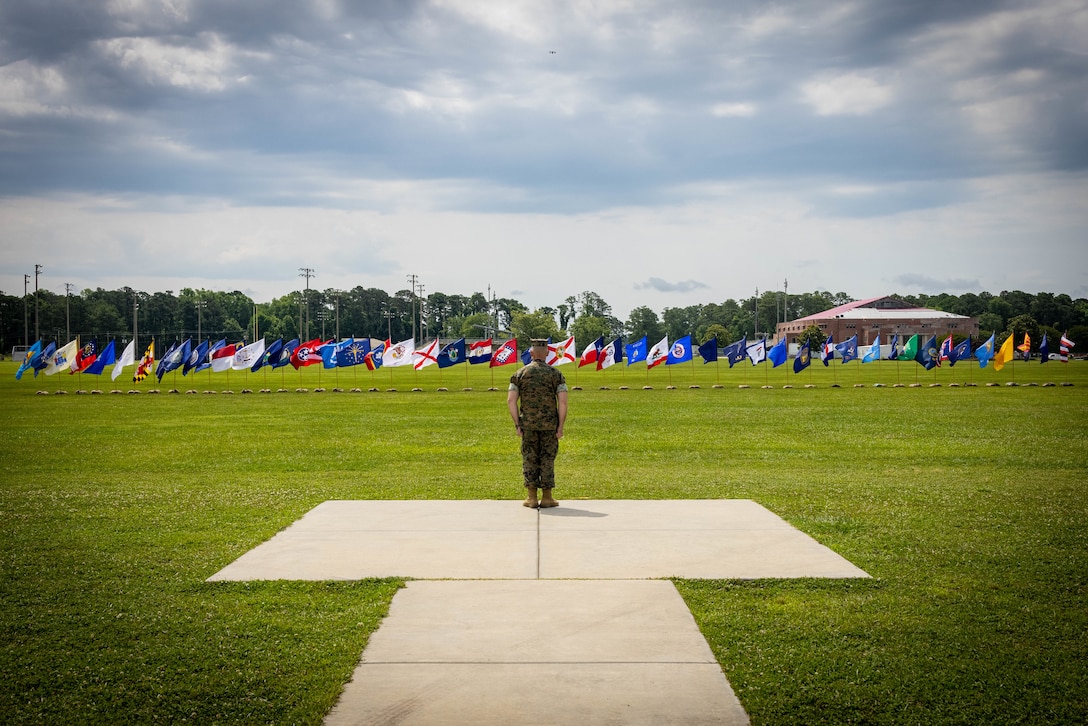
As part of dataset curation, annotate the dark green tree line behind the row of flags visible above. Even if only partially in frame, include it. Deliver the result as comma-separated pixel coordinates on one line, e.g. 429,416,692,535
0,286,1088,352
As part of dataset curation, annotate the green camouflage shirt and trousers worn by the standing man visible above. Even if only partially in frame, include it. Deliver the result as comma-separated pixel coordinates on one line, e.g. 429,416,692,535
510,360,567,489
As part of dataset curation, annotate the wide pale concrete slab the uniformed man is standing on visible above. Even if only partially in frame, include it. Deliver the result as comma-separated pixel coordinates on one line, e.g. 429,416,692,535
209,500,868,580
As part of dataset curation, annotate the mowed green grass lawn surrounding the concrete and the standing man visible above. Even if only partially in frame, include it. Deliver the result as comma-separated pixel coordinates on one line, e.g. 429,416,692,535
0,360,1088,724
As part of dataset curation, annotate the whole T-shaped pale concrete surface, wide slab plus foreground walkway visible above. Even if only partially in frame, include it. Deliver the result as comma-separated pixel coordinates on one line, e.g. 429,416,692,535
209,500,868,725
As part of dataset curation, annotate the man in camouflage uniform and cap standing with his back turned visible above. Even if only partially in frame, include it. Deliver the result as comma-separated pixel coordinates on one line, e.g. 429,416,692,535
506,340,567,508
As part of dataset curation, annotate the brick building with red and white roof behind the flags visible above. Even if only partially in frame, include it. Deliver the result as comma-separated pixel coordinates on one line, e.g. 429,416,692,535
775,296,978,346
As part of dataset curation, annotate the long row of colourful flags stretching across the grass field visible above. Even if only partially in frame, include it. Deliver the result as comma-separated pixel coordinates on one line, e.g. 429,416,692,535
15,333,1074,382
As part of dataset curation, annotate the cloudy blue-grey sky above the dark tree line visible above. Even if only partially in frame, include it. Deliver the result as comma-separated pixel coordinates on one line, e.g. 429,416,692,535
0,0,1088,318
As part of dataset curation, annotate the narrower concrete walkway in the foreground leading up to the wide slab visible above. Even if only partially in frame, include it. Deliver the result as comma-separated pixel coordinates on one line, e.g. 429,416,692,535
325,580,749,725
